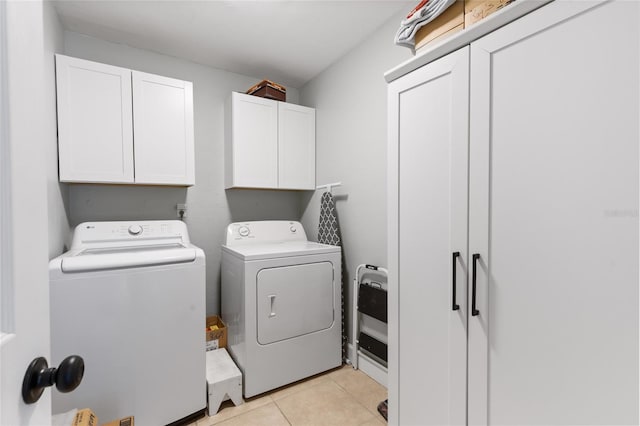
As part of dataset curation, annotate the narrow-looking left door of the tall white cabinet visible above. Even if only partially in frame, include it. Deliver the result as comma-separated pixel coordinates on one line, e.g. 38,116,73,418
389,47,469,425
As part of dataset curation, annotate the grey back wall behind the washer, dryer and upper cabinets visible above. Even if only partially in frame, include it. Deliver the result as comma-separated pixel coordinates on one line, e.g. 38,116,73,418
64,32,300,314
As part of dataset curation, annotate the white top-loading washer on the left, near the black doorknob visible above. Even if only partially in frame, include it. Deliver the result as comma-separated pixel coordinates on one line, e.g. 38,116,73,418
49,221,206,426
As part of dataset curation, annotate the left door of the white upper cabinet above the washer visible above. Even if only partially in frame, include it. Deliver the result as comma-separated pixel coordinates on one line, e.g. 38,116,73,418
56,55,133,183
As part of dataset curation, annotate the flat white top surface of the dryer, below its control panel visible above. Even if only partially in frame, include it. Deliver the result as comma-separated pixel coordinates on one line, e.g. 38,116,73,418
222,241,340,261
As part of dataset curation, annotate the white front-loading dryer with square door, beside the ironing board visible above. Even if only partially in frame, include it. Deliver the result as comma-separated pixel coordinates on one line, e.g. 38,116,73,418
221,221,342,397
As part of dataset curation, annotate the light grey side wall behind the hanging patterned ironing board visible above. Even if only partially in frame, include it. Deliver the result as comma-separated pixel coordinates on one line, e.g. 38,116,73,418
300,10,411,346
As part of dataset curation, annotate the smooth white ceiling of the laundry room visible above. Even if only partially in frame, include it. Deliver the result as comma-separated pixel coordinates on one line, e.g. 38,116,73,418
54,0,418,88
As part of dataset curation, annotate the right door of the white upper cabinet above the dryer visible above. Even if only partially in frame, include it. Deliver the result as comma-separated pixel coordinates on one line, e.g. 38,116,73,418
278,102,316,189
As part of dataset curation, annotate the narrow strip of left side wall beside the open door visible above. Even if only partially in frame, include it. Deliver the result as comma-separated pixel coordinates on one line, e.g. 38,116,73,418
42,1,69,259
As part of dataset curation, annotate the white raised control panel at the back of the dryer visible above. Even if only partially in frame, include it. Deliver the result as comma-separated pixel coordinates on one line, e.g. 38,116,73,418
225,220,307,246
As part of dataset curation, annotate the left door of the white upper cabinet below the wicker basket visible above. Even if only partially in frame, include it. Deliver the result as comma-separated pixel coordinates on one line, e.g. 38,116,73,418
225,92,278,188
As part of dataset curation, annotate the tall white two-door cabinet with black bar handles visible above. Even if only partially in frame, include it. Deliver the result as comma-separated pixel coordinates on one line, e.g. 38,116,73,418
389,1,640,425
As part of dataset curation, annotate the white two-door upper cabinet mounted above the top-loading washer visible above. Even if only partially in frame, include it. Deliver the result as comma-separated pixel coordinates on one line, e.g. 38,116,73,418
56,55,195,185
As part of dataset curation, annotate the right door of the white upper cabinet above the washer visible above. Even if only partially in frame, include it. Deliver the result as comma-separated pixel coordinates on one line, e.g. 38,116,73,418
132,71,195,185
